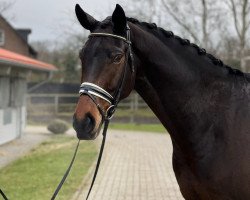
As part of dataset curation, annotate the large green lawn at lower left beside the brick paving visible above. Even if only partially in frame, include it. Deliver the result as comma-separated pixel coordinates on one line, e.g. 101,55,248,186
0,135,97,200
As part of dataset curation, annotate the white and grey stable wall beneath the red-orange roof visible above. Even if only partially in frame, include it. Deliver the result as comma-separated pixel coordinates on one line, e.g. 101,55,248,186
0,77,27,144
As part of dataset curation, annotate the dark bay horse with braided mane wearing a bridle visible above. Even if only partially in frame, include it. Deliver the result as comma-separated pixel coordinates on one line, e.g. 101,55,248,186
73,5,250,200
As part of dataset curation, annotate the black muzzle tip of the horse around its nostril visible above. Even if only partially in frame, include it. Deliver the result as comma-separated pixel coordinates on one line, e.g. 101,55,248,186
73,113,95,139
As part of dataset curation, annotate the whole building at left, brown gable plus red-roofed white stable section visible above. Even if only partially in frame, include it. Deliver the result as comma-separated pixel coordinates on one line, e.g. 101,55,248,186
0,15,57,144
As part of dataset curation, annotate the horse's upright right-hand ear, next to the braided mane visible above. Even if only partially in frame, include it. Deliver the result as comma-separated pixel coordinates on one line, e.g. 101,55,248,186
112,4,127,34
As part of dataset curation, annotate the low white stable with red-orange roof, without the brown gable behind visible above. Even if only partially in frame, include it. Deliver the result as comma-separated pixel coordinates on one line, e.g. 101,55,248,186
0,48,56,144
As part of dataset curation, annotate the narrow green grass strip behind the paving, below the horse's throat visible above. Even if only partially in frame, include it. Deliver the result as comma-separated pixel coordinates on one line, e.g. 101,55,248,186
109,122,167,133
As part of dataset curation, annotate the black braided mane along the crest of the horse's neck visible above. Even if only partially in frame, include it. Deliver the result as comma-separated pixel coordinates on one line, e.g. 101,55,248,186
127,18,244,76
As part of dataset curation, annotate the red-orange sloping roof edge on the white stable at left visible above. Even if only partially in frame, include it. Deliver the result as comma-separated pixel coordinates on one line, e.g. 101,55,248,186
0,48,57,71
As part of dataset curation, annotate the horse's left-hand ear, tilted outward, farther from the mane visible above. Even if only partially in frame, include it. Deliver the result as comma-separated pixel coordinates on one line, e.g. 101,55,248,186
75,4,98,32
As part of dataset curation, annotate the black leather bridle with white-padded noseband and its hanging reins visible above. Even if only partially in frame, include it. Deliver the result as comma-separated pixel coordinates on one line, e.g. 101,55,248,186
0,24,135,200
